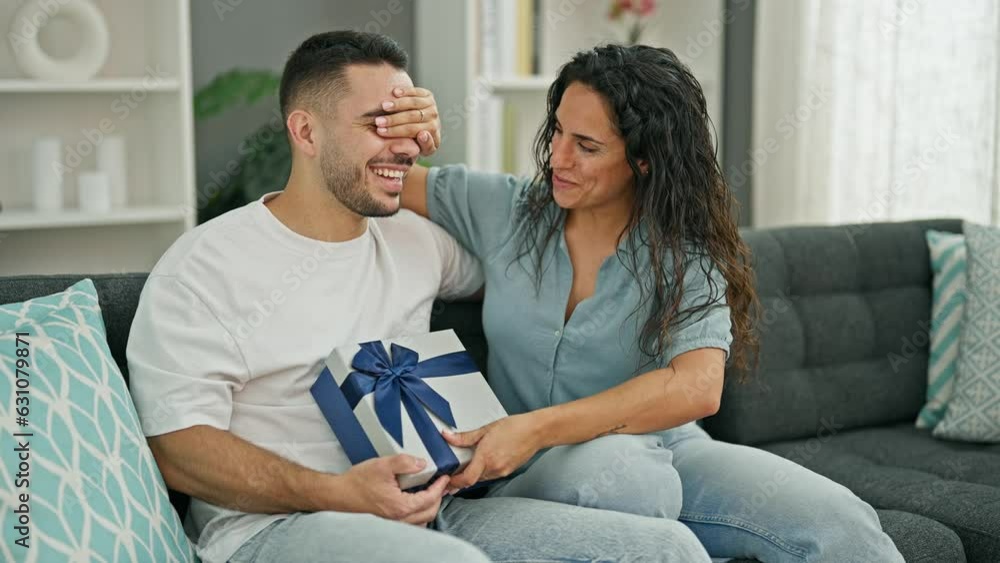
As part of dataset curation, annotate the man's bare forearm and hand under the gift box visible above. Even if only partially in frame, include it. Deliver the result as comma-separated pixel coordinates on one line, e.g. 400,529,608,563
148,425,448,524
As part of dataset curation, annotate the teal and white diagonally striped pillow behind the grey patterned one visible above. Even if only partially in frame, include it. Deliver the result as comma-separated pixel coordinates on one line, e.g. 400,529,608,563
917,230,966,428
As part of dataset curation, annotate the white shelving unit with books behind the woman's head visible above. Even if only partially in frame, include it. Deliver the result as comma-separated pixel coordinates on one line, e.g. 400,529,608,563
415,0,726,174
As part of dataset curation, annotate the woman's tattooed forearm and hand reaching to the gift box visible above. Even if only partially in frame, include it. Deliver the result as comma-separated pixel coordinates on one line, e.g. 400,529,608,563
445,348,726,491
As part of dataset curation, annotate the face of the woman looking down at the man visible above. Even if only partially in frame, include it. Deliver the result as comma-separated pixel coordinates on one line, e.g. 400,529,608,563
549,82,633,214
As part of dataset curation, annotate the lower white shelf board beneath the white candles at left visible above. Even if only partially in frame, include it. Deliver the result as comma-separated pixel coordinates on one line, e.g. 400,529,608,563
0,205,188,232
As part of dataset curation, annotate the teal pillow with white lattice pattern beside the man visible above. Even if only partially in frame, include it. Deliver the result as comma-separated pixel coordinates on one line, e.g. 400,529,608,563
0,279,195,562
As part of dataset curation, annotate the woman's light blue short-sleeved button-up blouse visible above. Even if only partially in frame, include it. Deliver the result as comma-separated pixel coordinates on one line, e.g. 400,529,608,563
427,165,732,414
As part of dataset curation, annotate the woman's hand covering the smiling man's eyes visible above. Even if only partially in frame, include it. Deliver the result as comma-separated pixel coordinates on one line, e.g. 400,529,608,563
375,87,441,156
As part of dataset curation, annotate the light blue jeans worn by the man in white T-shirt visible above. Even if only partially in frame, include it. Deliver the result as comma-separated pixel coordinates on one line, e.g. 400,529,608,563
230,486,709,563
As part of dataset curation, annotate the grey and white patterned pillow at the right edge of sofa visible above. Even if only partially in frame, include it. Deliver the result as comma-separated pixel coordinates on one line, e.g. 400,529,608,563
934,223,1000,442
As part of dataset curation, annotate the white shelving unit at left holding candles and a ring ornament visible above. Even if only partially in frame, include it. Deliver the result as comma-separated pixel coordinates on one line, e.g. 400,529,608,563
0,0,197,275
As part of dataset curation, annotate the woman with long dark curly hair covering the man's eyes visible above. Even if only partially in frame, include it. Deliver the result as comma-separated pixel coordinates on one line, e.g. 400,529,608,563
378,45,903,562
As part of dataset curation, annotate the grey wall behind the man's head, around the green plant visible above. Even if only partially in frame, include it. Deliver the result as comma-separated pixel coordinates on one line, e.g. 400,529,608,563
191,0,415,212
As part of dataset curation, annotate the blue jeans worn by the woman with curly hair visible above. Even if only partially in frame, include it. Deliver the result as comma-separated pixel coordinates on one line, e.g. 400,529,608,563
488,422,903,563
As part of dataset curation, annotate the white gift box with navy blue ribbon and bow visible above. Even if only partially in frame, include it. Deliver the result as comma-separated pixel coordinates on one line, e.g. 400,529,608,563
311,330,507,490
